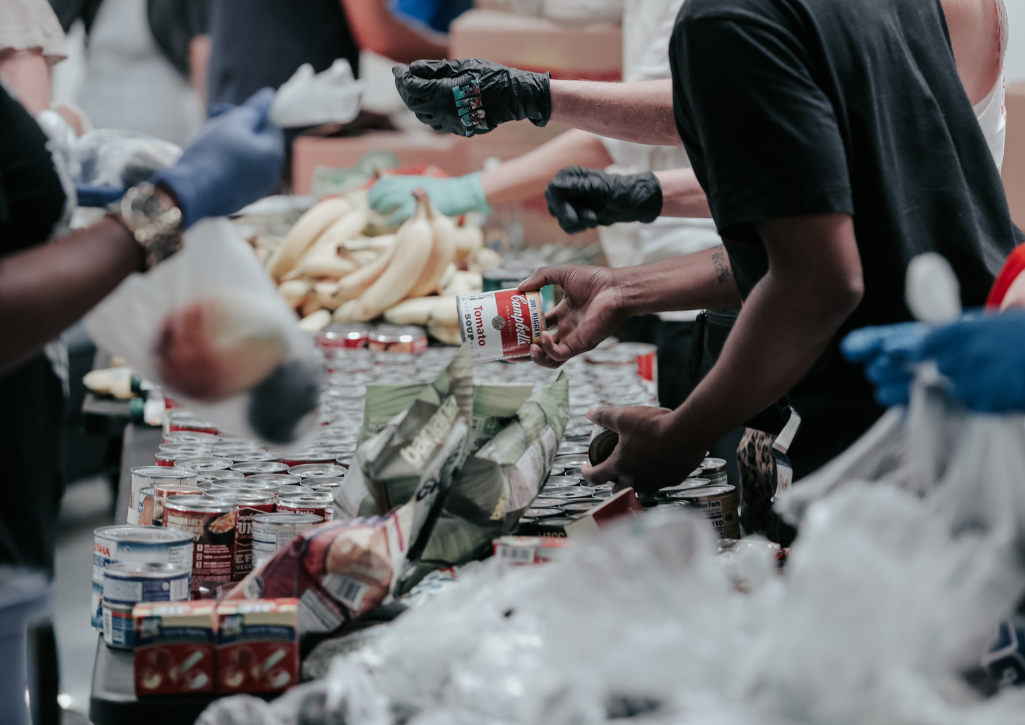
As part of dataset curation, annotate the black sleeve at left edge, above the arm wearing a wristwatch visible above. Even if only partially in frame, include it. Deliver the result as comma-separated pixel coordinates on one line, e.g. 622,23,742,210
0,86,65,256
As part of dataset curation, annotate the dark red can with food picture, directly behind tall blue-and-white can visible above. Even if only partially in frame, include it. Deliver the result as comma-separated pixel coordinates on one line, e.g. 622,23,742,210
164,496,238,599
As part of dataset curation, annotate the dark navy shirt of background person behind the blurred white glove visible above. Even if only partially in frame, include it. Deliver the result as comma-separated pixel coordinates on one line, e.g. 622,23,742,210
207,0,360,104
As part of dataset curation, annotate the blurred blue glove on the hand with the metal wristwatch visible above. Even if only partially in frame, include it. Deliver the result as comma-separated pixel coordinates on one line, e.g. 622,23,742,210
150,88,285,229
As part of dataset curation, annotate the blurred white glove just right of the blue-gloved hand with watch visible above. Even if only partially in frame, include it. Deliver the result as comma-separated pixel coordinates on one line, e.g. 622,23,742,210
269,58,367,128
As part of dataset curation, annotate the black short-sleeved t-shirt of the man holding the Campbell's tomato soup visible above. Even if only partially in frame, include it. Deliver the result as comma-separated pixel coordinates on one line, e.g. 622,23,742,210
669,0,1020,477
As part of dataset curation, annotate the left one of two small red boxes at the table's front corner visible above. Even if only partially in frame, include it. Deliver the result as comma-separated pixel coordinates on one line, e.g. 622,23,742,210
132,601,216,697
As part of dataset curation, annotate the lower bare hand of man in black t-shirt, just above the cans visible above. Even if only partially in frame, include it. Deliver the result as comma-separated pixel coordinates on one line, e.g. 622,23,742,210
582,407,705,493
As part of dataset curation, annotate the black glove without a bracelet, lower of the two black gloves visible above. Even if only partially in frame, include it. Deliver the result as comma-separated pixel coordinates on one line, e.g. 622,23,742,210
544,166,662,234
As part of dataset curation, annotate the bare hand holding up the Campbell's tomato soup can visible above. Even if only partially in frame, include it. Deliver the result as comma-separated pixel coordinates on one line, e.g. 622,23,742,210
520,265,629,367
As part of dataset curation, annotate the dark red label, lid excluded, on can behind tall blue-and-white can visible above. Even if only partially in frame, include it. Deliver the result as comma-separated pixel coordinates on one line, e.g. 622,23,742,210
164,505,236,599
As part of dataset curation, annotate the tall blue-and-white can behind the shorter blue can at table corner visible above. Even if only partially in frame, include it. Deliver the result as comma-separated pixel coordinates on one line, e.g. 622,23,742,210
90,526,193,630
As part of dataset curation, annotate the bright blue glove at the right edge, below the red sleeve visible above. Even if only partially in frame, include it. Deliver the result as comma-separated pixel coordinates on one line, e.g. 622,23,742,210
920,312,1025,413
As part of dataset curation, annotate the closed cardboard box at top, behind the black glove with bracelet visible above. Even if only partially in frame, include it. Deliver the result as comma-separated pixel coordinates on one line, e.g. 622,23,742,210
449,10,623,81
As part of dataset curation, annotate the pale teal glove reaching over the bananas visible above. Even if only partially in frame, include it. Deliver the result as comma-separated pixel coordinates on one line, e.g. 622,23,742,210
368,173,491,227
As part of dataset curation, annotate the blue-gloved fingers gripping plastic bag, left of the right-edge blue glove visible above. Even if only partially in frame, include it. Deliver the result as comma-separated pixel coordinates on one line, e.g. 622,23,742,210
841,322,930,407
